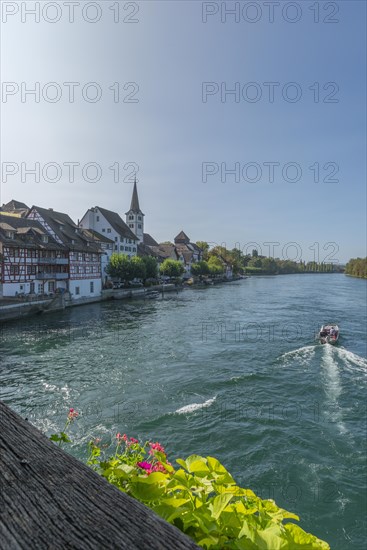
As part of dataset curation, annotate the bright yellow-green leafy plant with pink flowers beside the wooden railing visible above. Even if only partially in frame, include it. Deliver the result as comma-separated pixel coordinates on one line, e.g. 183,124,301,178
89,440,329,550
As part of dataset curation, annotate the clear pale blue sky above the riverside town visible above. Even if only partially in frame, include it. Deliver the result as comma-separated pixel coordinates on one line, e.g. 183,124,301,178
0,0,366,263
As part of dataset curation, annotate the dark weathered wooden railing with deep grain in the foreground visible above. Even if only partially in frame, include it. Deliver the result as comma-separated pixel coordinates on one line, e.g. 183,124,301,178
0,402,198,550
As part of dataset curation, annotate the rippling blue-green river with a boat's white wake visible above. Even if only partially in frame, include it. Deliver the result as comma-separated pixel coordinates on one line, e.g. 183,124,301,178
0,274,367,550
